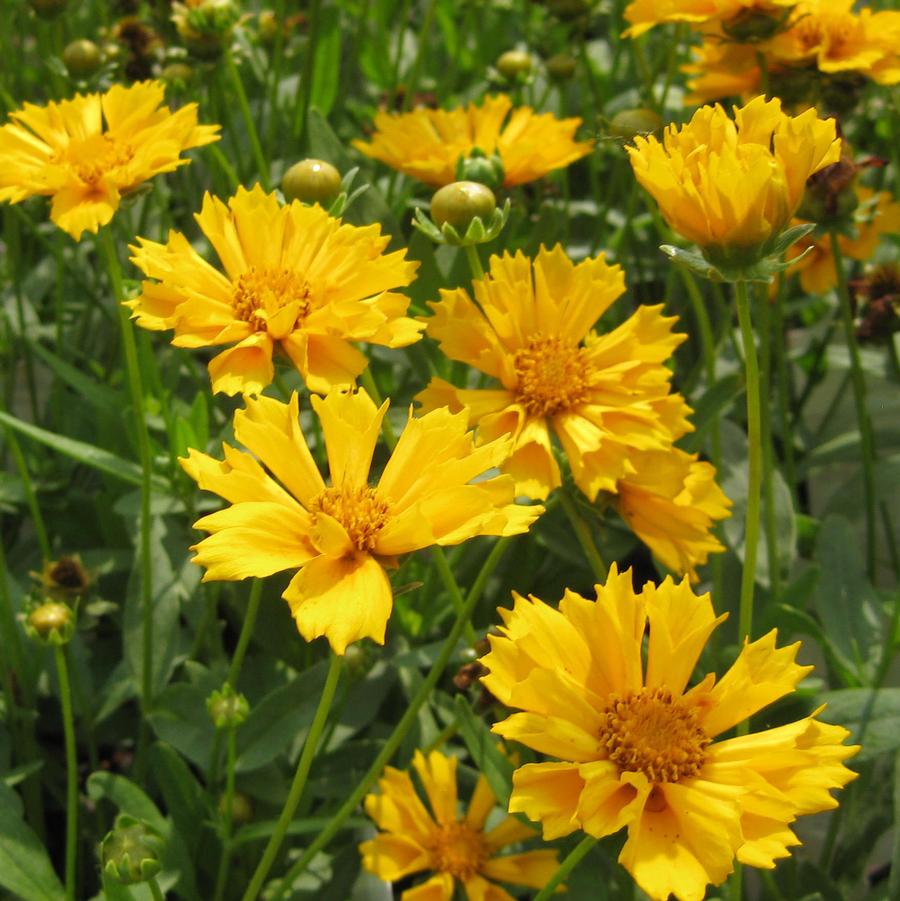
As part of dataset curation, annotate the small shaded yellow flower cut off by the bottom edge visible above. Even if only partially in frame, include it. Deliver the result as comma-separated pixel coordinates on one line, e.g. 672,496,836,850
359,751,557,901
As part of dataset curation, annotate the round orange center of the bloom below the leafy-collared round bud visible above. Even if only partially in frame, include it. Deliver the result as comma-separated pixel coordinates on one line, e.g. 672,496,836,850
513,335,590,416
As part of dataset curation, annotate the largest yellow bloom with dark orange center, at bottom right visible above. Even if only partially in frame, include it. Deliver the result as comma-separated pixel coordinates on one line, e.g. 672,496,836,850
482,567,858,901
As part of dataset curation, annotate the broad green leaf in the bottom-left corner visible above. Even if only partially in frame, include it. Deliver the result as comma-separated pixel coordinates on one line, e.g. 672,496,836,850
0,783,65,901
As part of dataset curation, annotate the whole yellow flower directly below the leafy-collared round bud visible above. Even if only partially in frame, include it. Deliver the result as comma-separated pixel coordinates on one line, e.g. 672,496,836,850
416,246,690,500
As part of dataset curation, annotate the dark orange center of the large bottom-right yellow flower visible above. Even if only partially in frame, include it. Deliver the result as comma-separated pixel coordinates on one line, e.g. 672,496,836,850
600,688,710,782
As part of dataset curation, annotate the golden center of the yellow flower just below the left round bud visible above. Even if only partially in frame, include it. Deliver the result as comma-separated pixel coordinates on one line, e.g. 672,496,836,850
231,266,310,339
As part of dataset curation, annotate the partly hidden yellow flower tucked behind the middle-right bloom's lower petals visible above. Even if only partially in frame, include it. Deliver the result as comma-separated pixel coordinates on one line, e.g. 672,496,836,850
616,447,731,582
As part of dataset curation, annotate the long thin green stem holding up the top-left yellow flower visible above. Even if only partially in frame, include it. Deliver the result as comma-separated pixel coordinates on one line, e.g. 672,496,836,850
100,226,153,728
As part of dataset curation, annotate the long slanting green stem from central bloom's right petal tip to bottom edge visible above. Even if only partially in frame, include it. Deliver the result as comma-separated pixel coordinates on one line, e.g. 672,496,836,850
272,538,511,901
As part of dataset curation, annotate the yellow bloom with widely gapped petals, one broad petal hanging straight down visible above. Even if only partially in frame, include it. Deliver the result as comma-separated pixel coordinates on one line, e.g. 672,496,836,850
181,391,543,654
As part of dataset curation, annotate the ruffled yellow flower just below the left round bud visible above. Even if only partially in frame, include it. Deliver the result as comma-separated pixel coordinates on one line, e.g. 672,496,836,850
127,185,422,394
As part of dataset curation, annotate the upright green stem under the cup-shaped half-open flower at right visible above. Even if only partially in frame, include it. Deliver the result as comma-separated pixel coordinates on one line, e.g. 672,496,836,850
734,281,762,660
